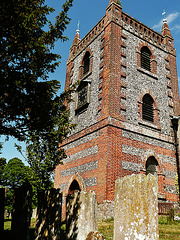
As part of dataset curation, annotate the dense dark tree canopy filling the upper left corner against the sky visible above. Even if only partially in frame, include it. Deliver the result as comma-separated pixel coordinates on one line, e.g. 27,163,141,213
0,0,73,140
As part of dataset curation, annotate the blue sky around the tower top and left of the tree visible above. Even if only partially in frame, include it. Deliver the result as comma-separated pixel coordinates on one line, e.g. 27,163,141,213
0,0,180,160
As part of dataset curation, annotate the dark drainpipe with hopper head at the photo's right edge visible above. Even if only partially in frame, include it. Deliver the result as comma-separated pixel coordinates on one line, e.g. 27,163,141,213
171,117,180,201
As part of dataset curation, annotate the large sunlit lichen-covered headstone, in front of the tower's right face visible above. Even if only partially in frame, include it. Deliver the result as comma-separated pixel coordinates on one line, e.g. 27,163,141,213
113,174,159,240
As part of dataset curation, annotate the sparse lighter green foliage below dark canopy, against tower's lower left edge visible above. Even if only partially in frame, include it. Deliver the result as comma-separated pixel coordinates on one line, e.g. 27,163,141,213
15,85,76,190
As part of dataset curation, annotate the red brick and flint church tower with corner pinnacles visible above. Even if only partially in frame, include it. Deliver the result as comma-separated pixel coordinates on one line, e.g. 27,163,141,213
54,0,179,214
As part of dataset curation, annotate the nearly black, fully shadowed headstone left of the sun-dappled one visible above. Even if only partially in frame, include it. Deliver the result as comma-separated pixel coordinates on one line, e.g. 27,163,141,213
11,183,32,240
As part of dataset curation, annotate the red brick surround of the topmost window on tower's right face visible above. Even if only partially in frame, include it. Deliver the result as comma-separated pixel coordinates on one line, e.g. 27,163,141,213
136,42,157,74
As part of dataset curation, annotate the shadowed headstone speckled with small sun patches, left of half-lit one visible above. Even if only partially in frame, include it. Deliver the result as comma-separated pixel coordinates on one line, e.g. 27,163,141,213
35,189,62,240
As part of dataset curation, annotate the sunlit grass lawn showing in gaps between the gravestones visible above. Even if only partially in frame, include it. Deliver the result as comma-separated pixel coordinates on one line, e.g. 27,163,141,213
4,219,180,240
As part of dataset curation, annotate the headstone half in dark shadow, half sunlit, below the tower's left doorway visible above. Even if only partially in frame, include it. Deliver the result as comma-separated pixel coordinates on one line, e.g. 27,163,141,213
66,192,97,240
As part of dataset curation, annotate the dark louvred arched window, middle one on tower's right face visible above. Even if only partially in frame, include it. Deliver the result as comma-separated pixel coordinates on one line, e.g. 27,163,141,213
142,94,154,122
